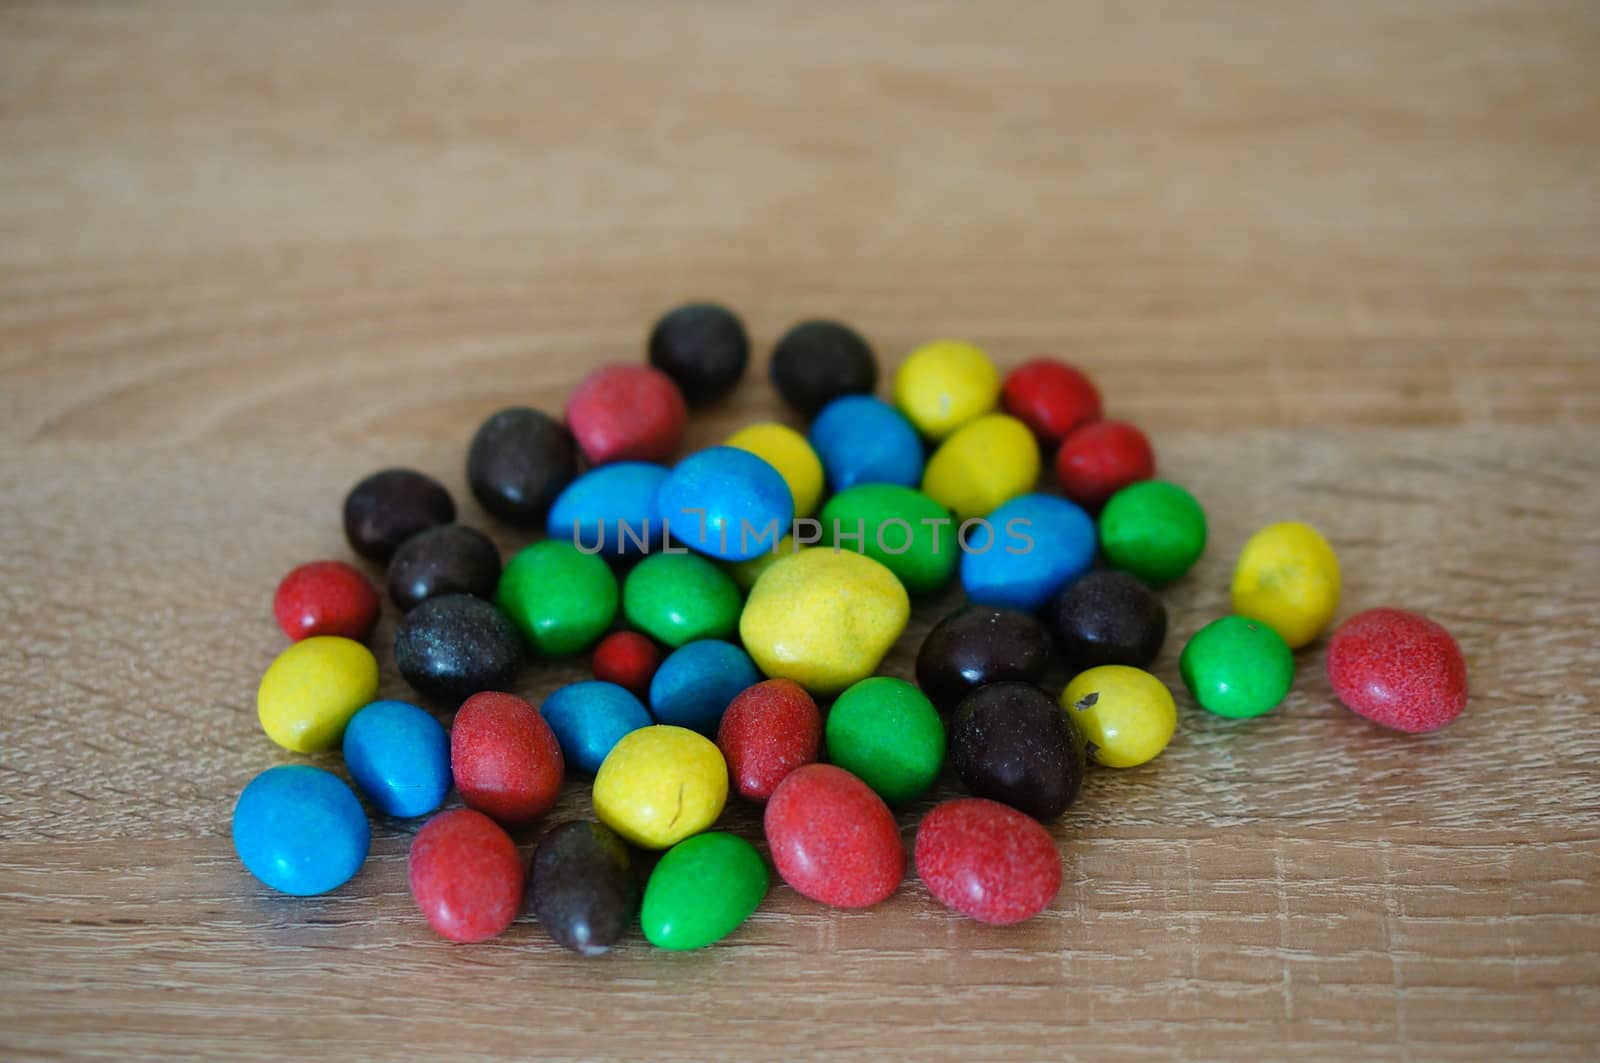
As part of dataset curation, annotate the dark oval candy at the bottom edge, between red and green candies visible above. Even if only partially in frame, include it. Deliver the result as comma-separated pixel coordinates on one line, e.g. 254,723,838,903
528,821,638,956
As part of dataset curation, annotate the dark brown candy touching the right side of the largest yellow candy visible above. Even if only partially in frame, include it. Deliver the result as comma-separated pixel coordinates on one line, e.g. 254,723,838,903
917,605,1050,712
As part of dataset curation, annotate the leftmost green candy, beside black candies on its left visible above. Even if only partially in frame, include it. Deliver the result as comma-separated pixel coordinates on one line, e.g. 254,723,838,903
494,540,618,656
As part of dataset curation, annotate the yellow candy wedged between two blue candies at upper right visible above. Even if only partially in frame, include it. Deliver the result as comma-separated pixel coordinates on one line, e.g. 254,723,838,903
922,413,1038,520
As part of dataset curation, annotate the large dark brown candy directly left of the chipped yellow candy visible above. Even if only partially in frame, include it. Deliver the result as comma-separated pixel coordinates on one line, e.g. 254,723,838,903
950,682,1085,820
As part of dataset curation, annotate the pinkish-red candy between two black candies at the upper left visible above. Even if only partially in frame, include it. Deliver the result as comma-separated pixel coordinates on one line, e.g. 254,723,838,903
566,365,688,466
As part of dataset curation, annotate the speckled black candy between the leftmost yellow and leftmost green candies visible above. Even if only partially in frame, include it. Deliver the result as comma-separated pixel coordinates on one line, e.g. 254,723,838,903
395,594,523,704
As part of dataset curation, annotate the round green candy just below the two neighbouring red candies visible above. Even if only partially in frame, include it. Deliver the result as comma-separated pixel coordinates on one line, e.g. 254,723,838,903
1099,480,1205,583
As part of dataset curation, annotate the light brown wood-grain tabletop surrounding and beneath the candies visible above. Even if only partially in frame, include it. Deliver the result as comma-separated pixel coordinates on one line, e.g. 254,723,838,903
0,0,1600,1060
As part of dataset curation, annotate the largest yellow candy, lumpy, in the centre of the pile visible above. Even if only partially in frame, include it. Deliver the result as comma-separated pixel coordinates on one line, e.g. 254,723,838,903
739,543,910,695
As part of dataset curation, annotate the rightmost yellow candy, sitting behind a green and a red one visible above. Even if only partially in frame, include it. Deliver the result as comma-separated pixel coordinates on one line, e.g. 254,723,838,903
1234,520,1339,650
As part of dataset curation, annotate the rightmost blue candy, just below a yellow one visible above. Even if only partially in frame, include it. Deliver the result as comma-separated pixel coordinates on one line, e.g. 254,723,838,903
962,495,1094,612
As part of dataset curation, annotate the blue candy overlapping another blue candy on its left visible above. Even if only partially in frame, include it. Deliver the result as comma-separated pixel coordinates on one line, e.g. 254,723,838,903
656,447,795,560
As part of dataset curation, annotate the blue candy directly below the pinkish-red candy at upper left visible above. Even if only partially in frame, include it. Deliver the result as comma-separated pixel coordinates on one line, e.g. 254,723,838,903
544,461,667,557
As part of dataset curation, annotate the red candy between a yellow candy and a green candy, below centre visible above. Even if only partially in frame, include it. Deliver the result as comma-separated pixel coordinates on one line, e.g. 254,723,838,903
717,679,822,800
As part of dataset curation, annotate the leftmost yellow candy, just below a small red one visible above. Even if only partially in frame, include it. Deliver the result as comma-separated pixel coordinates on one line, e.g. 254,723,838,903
256,636,378,752
